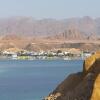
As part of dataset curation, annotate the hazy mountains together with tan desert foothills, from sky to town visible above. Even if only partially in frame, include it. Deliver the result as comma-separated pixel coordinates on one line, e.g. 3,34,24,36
0,16,100,50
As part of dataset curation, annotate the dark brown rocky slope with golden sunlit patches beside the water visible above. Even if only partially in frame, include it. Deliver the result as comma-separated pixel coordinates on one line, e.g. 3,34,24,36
44,52,100,100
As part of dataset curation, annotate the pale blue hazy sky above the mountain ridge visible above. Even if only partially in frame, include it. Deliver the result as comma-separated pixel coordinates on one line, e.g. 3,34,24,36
0,0,100,19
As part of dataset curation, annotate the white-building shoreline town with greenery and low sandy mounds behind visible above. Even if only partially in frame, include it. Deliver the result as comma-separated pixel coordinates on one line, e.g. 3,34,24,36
0,48,94,60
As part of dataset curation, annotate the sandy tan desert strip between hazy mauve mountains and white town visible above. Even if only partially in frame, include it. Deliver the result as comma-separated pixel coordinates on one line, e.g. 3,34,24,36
0,34,100,51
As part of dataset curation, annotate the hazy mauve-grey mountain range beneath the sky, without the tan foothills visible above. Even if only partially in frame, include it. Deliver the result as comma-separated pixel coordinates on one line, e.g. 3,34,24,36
0,16,100,39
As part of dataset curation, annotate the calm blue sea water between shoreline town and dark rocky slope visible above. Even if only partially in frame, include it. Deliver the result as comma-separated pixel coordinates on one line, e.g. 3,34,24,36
0,60,83,100
